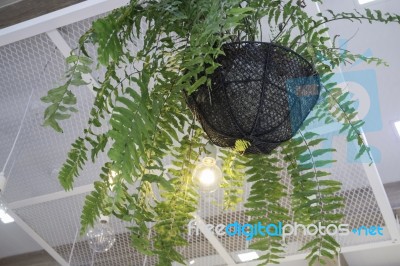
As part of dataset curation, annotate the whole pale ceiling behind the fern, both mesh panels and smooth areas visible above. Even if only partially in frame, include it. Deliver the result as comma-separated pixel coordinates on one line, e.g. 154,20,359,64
0,0,400,266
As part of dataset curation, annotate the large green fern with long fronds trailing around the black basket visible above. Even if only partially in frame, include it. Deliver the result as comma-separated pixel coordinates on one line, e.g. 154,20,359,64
42,0,400,266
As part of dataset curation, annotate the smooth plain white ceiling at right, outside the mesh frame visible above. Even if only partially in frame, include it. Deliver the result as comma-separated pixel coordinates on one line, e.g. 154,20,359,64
321,0,400,183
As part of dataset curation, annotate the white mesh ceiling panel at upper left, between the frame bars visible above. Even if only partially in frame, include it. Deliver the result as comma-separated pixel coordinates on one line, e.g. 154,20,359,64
0,34,109,202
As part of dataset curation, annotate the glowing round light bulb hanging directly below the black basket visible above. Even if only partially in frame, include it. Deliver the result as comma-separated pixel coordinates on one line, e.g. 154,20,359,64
192,157,222,192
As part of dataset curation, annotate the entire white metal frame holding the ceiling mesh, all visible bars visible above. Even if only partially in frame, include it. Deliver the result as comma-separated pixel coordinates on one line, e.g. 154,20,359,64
0,0,400,266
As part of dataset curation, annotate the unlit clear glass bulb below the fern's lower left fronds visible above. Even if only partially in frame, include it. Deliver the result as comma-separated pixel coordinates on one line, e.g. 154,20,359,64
87,216,115,252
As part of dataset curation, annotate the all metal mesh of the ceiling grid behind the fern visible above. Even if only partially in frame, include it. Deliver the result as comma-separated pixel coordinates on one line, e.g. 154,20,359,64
0,10,390,265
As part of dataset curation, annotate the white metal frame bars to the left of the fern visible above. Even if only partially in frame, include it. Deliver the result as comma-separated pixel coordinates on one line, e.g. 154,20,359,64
0,0,129,266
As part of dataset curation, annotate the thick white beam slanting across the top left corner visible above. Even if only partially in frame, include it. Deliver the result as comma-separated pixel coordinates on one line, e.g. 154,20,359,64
0,0,129,46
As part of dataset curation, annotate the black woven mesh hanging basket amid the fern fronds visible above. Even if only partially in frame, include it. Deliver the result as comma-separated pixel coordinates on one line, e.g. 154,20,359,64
187,42,321,154
